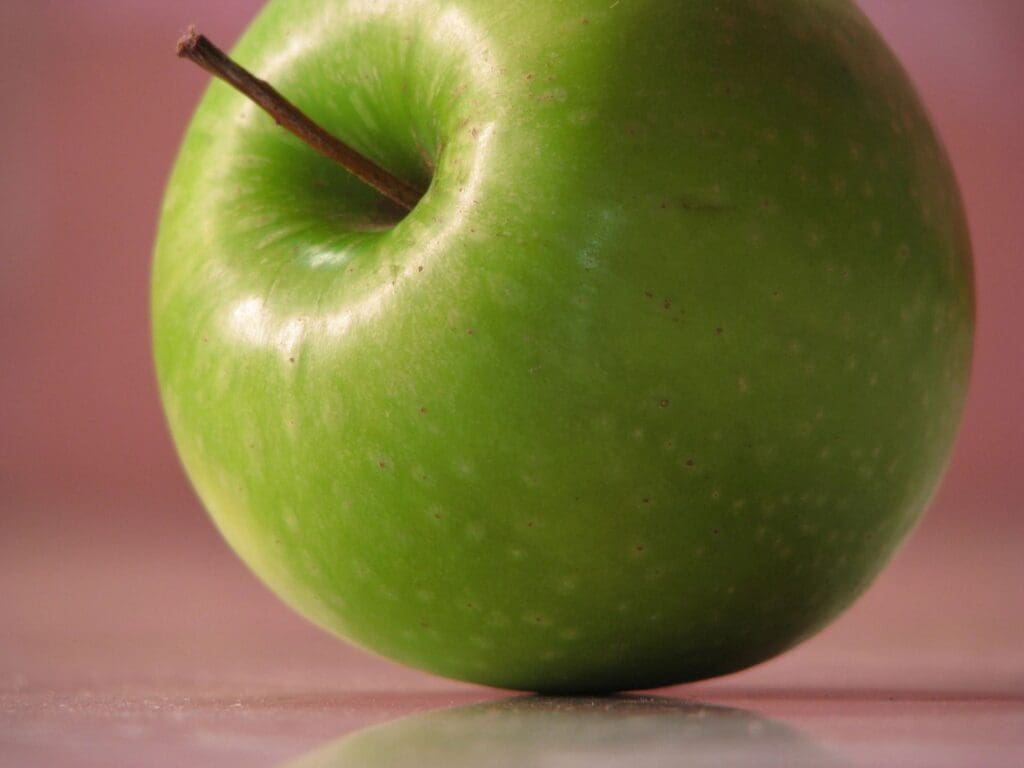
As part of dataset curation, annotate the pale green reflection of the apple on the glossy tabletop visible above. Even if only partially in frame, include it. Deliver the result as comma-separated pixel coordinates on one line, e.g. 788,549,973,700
282,697,845,768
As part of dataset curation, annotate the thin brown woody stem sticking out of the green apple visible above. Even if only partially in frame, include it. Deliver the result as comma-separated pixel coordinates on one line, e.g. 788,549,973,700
178,27,423,211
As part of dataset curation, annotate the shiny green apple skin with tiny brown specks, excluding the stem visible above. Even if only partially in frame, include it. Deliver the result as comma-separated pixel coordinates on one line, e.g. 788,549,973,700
152,0,974,692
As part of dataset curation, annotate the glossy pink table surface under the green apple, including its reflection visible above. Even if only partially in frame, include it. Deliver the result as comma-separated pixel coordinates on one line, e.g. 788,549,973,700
0,501,1024,768
